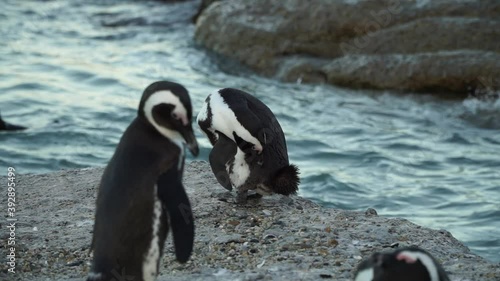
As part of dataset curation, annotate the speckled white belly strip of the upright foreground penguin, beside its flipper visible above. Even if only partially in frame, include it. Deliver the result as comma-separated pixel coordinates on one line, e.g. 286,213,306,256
142,185,162,281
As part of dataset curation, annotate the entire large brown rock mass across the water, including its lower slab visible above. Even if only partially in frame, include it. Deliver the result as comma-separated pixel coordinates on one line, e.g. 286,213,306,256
195,0,500,92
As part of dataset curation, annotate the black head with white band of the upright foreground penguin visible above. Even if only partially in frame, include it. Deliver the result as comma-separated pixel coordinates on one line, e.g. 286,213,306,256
138,81,199,156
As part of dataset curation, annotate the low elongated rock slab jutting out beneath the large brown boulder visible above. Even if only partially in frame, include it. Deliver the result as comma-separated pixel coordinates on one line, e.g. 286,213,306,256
323,50,500,94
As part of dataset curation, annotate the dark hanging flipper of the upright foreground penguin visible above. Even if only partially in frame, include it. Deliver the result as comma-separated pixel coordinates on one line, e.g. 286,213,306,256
157,166,194,263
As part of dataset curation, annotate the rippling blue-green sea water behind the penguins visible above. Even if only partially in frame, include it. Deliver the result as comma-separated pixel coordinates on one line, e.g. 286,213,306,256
0,0,500,262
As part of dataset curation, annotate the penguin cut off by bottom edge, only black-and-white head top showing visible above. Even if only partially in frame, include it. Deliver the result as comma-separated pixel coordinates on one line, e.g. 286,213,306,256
354,246,450,281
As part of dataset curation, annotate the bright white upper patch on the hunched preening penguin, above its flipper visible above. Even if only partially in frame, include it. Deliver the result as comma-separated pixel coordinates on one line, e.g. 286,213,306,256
208,92,262,151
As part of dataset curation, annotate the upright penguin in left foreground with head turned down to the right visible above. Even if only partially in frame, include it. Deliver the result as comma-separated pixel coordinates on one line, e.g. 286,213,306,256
87,81,198,281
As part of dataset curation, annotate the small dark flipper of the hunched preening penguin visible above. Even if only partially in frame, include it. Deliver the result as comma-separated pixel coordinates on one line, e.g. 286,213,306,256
208,134,238,191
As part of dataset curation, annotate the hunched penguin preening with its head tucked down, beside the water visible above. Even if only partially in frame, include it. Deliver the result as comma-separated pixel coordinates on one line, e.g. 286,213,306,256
197,88,300,203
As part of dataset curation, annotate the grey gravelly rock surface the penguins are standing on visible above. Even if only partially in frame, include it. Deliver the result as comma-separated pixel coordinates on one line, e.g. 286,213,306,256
0,161,500,281
